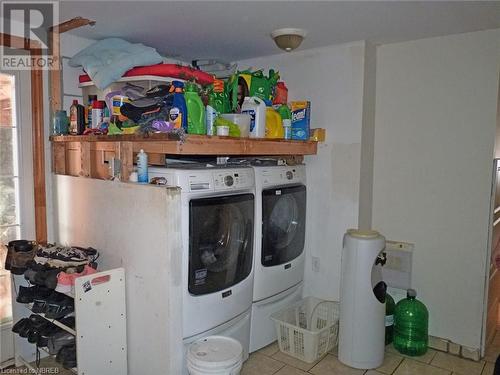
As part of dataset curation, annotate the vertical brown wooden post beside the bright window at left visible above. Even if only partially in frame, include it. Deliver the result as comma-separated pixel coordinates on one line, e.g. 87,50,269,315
30,49,47,243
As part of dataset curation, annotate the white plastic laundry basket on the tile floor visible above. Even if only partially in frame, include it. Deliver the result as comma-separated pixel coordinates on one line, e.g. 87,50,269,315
271,297,339,363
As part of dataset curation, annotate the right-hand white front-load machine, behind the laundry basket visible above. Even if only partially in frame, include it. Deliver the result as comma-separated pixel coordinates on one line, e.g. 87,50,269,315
250,165,306,352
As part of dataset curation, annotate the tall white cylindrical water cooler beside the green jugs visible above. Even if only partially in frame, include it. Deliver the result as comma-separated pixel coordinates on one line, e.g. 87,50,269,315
339,229,385,369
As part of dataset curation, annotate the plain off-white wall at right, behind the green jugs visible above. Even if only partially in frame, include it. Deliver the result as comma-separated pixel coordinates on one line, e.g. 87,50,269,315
373,30,500,348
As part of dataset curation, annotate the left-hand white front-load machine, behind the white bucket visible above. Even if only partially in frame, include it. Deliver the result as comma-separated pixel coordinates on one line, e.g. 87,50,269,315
149,164,254,353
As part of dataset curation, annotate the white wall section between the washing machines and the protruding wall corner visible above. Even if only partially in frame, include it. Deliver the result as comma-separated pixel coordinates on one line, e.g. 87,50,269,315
239,42,365,300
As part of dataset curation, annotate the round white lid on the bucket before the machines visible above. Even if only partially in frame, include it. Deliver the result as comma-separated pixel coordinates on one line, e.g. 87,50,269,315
187,336,243,368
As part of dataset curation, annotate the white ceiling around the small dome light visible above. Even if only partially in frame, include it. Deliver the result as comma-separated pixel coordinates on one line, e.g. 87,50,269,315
60,0,500,61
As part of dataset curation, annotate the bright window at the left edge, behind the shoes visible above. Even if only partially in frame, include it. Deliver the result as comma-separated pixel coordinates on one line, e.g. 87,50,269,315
0,73,20,324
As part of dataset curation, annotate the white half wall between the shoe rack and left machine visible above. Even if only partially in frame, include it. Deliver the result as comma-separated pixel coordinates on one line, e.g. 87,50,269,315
53,175,184,375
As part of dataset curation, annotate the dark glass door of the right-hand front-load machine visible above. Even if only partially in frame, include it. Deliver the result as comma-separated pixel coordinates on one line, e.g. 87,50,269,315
261,185,306,267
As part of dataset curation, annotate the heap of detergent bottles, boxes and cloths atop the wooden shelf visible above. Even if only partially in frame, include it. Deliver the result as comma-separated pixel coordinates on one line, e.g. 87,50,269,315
52,40,324,148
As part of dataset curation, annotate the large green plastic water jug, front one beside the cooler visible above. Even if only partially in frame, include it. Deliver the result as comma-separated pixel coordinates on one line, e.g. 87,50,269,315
394,289,429,356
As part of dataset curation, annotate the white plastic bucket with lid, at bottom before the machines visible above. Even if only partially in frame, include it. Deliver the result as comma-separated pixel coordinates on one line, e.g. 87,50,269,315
187,336,243,375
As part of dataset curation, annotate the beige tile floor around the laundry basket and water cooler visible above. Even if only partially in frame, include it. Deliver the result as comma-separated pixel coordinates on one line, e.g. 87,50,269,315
241,331,500,375
